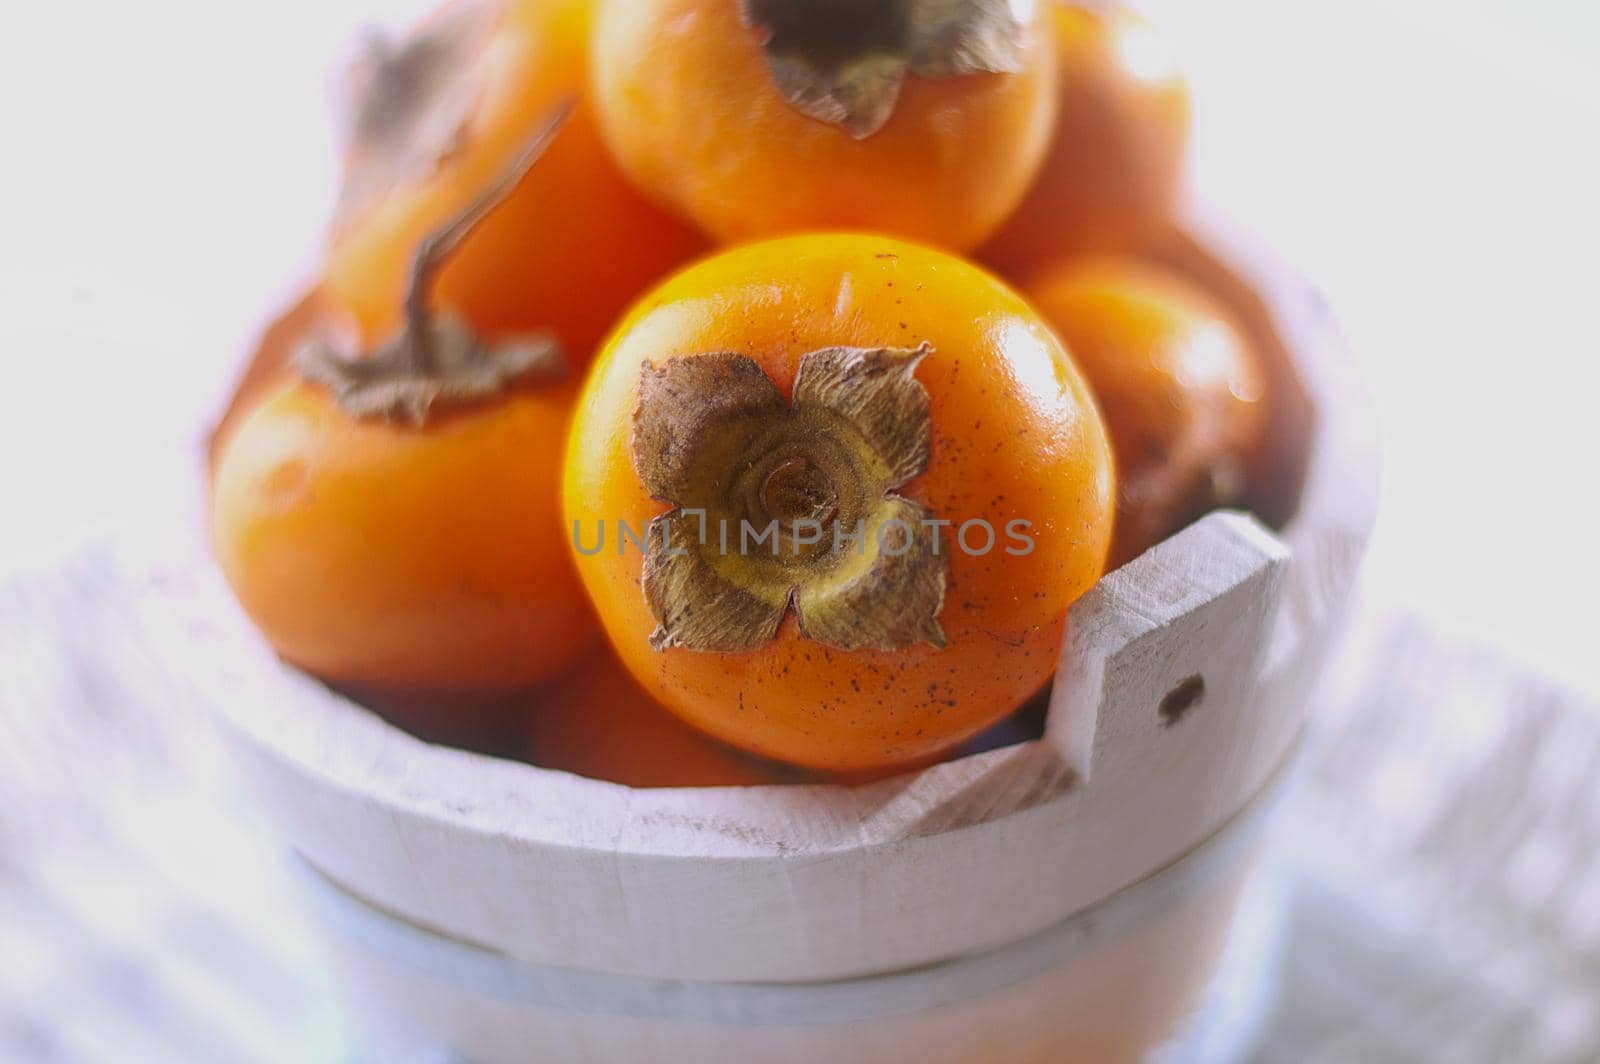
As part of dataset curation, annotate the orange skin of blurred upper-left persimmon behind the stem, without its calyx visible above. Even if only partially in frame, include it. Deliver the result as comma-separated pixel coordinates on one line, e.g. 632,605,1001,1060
326,0,706,366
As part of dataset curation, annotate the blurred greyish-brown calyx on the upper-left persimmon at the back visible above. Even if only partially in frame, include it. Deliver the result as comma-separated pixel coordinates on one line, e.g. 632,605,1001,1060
334,0,504,230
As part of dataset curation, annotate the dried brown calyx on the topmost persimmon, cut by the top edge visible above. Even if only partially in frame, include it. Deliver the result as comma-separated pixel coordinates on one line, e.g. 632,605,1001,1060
739,0,1032,139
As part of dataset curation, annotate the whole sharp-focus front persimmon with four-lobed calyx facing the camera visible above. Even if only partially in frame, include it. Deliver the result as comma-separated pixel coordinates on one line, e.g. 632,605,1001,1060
563,234,1114,771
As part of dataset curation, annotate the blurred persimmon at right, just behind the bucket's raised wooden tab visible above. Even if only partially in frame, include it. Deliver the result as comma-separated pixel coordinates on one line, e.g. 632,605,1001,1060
1027,258,1267,565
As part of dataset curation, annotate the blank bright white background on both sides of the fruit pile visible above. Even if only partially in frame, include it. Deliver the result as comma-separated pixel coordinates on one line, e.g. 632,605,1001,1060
0,0,1600,690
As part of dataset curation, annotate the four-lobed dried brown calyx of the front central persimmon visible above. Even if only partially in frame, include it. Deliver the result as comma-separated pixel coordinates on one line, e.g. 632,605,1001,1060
632,344,947,653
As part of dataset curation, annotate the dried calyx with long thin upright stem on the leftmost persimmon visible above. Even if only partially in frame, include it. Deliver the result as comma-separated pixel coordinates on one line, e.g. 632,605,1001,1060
294,102,573,424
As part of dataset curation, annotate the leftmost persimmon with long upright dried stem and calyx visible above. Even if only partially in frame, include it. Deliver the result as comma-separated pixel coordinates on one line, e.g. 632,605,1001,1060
211,105,598,693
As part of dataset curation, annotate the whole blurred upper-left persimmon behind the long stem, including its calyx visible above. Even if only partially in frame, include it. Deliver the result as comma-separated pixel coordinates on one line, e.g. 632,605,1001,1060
326,0,706,365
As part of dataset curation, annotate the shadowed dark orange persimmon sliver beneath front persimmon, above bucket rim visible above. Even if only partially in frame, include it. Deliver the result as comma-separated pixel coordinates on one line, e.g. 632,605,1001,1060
525,648,782,787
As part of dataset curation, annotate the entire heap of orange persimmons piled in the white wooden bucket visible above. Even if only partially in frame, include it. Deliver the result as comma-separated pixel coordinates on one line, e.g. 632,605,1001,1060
213,0,1294,786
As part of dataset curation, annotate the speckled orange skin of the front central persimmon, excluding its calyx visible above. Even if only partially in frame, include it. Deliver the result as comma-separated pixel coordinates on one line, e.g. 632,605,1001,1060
563,234,1114,771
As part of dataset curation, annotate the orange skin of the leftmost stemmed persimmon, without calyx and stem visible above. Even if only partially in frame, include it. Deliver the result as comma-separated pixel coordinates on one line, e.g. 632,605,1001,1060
211,382,598,693
